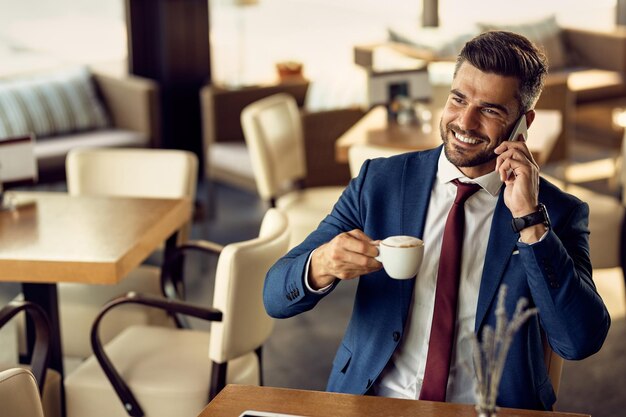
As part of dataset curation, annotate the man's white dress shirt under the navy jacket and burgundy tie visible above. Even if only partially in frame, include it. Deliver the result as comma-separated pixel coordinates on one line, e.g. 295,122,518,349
373,152,502,403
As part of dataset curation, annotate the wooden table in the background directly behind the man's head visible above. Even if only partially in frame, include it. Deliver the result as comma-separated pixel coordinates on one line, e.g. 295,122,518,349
335,106,561,165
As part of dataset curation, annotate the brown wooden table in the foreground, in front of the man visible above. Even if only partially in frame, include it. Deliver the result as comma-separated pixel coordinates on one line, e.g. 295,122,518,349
198,385,589,417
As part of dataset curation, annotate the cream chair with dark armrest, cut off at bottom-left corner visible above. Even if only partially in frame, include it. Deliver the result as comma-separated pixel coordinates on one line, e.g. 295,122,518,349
0,300,61,417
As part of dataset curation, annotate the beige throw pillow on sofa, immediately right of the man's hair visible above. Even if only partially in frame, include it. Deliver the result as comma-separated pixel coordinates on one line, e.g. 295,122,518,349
478,16,568,70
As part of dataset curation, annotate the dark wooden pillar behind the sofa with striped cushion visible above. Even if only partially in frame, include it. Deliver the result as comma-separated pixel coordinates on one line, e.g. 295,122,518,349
126,0,211,167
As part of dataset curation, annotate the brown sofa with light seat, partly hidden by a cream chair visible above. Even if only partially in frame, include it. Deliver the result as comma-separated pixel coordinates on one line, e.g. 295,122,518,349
200,79,365,192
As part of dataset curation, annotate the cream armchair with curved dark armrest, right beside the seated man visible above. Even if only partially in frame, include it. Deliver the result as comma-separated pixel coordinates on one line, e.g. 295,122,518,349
65,209,289,417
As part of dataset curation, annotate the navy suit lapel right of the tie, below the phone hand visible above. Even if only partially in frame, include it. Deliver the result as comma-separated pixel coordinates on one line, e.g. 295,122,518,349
474,190,519,332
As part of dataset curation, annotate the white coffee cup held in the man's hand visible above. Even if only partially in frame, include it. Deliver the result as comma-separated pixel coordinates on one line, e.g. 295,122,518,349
376,235,424,279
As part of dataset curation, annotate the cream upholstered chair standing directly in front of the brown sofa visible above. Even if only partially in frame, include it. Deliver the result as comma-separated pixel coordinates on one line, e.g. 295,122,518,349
241,93,344,247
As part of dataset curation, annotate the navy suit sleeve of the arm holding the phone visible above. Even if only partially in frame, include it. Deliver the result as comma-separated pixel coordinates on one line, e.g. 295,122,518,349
518,201,611,360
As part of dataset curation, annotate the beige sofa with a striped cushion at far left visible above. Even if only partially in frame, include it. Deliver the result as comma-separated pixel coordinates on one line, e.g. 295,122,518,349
0,67,160,182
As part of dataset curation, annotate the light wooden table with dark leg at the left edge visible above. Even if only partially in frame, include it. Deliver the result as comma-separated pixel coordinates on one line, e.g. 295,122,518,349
0,192,191,375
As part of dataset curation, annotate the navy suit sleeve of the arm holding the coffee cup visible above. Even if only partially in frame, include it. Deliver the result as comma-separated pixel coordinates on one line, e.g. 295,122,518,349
263,161,370,318
